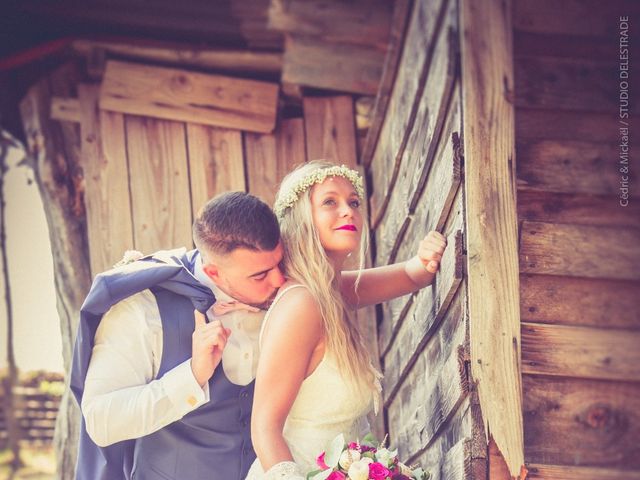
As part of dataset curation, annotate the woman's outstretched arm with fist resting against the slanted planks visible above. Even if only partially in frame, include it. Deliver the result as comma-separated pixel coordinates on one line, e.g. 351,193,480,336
341,231,447,308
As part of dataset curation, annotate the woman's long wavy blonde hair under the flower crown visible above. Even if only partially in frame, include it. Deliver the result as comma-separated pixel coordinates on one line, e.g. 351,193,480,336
276,160,375,389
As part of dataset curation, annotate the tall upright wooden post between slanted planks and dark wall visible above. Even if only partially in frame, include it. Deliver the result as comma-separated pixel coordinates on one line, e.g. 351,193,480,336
460,0,524,476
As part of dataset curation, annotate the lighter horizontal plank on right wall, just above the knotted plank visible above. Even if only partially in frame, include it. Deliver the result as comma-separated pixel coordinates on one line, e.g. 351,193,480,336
522,322,640,381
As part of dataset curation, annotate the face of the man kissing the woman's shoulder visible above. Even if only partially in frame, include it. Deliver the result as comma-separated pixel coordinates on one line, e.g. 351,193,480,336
203,243,285,308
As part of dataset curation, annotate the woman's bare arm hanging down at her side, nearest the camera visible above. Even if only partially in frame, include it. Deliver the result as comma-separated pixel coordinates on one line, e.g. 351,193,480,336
251,288,323,472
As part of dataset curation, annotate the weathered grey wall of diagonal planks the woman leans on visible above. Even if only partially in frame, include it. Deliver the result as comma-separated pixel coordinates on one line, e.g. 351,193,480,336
362,0,487,480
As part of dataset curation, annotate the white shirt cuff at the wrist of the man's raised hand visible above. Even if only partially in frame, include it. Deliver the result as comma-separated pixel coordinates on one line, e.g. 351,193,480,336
161,359,209,416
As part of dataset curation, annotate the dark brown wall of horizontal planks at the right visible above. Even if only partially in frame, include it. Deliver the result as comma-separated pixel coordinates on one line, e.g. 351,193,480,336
513,0,640,479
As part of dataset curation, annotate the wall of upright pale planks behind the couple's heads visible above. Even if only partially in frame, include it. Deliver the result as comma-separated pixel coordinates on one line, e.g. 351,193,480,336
51,62,364,275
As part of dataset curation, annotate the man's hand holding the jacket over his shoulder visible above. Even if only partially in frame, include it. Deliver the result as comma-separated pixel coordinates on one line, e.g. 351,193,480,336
191,310,231,388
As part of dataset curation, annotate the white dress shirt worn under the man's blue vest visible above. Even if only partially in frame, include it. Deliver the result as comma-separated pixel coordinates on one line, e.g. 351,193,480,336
82,258,264,446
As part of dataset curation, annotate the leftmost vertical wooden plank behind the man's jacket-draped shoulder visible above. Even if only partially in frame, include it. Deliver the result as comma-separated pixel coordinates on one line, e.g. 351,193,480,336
77,84,133,275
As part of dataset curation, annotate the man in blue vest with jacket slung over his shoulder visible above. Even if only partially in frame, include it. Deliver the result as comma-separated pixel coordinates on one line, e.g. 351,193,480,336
71,192,284,480
